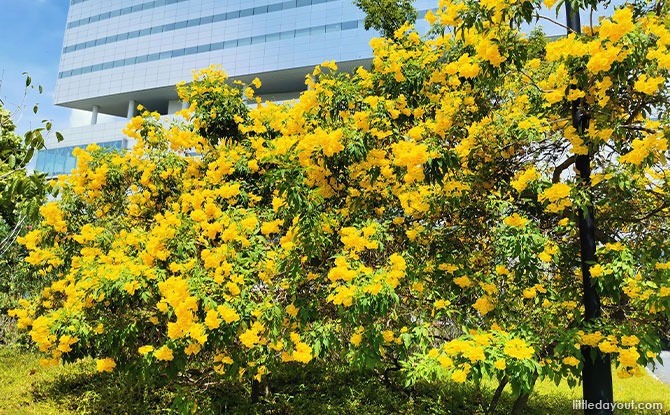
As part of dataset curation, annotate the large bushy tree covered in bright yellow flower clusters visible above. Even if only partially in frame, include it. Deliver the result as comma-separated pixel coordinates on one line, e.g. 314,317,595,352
11,1,670,410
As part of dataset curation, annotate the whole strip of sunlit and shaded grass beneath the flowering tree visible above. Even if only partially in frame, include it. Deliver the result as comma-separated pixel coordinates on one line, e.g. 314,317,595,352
0,347,670,415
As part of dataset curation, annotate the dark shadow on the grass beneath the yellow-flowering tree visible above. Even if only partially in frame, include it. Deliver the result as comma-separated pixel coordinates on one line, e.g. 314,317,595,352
28,365,632,415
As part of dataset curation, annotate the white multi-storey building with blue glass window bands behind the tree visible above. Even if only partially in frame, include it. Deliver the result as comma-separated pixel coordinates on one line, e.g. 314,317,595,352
37,0,434,174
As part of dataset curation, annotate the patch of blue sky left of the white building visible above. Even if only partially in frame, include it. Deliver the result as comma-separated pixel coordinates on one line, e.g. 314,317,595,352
0,0,71,132
